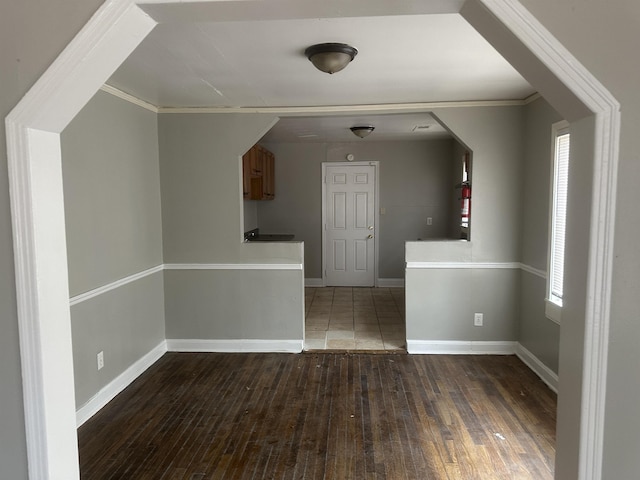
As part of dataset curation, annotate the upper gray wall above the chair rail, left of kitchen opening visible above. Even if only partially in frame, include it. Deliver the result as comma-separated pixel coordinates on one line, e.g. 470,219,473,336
158,114,275,263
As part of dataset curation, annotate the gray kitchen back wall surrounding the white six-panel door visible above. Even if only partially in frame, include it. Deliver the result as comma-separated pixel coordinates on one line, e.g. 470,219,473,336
258,140,454,278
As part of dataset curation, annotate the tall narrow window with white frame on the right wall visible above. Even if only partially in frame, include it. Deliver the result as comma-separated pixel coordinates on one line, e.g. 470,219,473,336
546,122,570,322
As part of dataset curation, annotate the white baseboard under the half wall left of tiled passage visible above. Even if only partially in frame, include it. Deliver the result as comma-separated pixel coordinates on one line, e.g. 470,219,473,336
167,339,304,353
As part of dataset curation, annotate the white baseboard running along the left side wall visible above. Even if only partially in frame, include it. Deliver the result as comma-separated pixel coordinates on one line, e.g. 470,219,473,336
76,340,167,427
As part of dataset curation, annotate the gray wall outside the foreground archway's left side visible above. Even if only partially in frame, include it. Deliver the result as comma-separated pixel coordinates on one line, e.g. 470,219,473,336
0,0,102,480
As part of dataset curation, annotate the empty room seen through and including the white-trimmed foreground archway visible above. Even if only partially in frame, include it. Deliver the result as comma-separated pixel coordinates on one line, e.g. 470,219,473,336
3,0,629,480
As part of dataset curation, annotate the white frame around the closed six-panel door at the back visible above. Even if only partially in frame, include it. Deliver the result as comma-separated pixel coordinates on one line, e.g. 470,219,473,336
321,160,380,287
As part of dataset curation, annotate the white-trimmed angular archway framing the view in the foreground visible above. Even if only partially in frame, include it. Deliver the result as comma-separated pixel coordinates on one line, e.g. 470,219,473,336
6,0,619,479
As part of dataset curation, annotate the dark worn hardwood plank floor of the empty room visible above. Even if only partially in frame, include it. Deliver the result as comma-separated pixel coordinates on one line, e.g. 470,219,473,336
78,353,556,480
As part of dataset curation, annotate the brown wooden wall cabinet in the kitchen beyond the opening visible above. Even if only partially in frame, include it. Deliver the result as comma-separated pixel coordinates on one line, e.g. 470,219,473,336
242,145,275,200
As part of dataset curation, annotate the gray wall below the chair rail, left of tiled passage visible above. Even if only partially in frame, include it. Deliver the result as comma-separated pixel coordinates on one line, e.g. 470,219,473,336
165,270,304,340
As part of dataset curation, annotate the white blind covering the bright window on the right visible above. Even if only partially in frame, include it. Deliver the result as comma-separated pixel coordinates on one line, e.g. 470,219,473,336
549,130,570,306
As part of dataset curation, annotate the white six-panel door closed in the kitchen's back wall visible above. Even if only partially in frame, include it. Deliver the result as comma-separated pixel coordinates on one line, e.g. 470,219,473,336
324,164,377,287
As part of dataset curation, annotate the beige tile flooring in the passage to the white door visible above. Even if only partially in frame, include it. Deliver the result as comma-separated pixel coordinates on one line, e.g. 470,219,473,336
304,287,406,351
